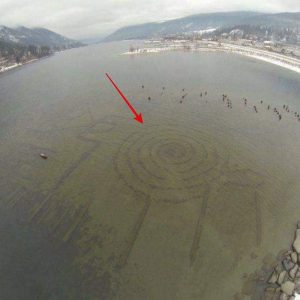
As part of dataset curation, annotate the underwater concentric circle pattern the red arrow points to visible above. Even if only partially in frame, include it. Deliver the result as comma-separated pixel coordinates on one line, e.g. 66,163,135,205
116,126,224,203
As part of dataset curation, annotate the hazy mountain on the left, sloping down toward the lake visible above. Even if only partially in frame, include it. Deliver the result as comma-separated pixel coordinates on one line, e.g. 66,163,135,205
0,26,83,48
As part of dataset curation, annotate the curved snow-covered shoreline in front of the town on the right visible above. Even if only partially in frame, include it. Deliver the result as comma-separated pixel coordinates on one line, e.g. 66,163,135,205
123,41,300,74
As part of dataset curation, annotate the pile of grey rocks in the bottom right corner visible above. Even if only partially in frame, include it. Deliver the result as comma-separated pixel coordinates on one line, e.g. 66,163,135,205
264,223,300,300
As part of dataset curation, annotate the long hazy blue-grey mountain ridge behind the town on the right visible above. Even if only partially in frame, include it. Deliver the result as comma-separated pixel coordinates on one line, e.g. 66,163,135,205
104,11,300,41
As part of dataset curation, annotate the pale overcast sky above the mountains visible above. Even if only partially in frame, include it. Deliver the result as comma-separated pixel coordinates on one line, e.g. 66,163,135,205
0,0,300,39
